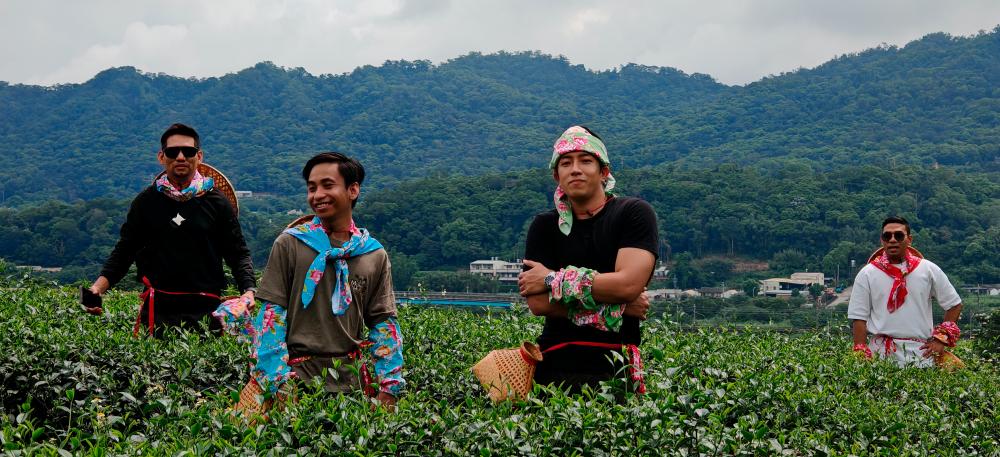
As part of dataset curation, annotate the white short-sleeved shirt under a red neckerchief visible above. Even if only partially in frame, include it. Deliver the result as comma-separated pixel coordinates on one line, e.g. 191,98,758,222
847,259,962,339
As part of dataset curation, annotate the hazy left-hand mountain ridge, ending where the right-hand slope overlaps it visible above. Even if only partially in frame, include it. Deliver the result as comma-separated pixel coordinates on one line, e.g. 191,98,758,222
0,53,726,203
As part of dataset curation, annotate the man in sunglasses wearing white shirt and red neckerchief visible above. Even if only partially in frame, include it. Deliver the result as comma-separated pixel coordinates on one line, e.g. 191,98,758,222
847,217,962,367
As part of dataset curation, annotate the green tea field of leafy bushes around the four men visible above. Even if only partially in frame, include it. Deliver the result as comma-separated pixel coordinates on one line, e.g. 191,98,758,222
0,284,1000,456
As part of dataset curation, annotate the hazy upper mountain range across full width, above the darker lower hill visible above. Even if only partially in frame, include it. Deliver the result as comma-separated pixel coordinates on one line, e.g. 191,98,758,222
0,28,1000,206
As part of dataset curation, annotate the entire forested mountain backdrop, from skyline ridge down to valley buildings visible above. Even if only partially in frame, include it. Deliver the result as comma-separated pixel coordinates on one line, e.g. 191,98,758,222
0,27,1000,287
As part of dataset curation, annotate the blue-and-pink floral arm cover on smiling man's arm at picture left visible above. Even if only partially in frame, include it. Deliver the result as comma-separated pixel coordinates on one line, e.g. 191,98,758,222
212,298,295,394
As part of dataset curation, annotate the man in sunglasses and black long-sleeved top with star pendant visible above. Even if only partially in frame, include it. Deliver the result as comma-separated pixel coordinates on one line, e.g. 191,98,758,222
82,124,256,336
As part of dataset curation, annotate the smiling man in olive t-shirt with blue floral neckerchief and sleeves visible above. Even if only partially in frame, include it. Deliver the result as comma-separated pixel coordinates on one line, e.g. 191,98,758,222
216,152,405,406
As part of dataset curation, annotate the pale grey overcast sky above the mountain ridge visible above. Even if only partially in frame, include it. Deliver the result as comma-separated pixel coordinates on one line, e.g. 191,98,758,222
0,0,1000,85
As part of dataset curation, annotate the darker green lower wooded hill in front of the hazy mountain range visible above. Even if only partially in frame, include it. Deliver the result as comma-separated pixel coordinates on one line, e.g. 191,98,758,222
0,164,1000,287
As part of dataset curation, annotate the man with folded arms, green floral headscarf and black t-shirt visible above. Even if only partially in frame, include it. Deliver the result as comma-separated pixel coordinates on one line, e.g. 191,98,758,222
518,126,659,393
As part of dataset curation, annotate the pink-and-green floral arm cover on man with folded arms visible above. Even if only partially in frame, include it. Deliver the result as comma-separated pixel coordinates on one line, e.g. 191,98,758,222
549,266,625,332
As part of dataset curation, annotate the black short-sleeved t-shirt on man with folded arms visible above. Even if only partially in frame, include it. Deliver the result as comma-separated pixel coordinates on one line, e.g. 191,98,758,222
524,197,659,383
